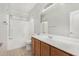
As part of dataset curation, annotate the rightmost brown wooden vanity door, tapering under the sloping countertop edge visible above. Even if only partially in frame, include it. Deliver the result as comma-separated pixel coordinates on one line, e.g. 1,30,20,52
51,47,70,56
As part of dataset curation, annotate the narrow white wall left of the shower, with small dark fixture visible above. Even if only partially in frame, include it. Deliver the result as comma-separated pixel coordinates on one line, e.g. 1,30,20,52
0,14,8,50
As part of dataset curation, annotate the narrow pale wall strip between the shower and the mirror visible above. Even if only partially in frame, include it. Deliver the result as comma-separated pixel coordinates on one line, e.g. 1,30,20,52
29,3,46,34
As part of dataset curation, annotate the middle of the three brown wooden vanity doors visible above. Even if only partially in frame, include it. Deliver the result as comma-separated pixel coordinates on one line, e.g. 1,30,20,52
41,42,50,56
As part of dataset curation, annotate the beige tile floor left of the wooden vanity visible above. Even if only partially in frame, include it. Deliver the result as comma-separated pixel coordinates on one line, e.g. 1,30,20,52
0,47,32,56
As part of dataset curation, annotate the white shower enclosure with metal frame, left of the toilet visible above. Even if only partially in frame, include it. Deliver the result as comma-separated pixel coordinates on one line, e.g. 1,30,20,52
8,16,29,50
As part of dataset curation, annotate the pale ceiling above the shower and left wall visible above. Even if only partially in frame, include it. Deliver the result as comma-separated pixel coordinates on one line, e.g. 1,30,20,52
0,3,36,16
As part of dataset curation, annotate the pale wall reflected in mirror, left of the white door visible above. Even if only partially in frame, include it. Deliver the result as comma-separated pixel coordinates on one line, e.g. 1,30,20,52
44,3,79,36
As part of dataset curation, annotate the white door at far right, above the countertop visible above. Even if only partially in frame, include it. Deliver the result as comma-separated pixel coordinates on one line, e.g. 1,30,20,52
70,11,79,37
